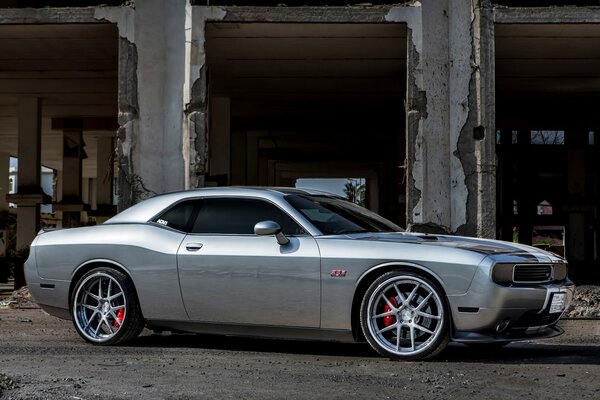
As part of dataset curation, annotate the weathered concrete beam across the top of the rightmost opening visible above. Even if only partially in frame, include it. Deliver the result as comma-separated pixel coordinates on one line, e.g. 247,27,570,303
493,6,600,24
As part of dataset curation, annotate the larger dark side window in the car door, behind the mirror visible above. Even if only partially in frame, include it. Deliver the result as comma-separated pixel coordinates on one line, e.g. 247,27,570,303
192,198,305,235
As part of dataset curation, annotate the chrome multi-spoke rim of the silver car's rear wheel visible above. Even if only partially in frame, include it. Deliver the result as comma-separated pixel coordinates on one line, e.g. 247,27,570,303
73,272,127,343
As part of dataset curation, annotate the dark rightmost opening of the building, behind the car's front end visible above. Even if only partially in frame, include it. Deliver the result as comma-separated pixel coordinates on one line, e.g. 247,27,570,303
495,24,600,283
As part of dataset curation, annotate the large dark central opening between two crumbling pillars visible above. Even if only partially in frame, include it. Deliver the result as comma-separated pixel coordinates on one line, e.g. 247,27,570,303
206,23,407,224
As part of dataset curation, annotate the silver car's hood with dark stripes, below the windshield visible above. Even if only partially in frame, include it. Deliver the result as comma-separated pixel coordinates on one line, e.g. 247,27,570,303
348,232,564,262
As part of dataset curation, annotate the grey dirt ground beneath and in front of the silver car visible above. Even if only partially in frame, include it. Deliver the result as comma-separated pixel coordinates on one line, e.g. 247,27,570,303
0,308,600,400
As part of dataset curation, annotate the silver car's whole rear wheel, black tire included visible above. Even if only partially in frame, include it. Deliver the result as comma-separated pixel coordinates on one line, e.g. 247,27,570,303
71,267,144,345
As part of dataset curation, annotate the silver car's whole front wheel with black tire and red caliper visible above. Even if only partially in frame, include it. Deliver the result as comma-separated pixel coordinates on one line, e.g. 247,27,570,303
360,270,450,361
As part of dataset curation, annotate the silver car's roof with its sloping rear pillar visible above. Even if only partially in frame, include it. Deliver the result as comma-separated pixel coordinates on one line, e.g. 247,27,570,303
105,186,336,224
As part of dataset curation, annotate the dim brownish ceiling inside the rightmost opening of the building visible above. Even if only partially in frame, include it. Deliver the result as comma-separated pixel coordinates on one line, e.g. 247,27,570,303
495,24,600,95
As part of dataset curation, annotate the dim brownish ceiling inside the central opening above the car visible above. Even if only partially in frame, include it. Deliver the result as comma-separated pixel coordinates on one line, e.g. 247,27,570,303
206,23,406,106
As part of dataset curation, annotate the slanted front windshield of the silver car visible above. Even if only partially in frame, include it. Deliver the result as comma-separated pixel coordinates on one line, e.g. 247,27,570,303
285,194,404,235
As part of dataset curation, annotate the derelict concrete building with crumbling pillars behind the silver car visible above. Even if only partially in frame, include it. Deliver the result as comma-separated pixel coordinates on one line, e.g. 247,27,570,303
0,0,600,282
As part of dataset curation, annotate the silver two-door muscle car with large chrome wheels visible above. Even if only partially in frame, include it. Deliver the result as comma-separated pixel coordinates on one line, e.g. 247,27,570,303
25,188,574,360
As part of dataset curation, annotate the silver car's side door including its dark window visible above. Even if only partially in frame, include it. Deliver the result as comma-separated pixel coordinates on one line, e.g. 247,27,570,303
177,197,321,327
